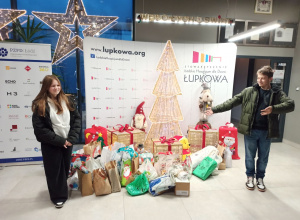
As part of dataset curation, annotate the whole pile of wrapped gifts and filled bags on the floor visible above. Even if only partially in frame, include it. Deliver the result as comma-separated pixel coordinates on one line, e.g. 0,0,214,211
68,123,239,196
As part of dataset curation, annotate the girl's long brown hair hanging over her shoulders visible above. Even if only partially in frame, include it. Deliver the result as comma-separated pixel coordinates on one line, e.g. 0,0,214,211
31,75,74,117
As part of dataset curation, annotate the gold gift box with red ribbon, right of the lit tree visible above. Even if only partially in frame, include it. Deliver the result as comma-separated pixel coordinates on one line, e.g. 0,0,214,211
188,124,219,153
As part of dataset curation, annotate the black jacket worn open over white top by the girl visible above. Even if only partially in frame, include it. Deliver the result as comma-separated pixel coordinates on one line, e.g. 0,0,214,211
32,99,81,147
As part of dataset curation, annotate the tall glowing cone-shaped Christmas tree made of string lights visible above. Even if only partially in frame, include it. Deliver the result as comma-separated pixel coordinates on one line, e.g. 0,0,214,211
144,41,183,150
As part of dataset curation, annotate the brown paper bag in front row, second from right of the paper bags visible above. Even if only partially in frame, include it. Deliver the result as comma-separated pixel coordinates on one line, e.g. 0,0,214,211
93,169,111,196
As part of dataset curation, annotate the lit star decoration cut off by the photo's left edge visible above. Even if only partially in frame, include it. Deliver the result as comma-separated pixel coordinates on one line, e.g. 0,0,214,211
0,9,26,40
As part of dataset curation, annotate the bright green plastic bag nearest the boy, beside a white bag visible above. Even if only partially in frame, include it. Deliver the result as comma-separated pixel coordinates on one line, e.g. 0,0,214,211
193,157,218,180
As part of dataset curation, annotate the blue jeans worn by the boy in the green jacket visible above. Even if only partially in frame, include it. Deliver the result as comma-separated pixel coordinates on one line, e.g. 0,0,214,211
244,129,271,179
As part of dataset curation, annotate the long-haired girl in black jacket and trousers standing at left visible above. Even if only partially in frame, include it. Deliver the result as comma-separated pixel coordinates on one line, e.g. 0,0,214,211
32,75,81,208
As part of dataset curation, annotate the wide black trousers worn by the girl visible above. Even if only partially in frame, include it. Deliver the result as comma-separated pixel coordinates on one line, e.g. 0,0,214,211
41,143,73,203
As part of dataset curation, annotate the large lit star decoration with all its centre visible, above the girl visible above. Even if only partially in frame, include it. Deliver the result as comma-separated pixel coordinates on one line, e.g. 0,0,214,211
32,0,118,64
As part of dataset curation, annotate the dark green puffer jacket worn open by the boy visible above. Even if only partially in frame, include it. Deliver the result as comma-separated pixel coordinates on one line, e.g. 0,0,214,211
212,83,295,138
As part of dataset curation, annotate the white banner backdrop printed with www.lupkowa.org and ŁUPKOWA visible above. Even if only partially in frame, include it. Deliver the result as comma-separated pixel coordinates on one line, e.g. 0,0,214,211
83,37,237,134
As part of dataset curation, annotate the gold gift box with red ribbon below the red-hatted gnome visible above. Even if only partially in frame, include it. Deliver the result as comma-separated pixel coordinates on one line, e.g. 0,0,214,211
107,128,146,146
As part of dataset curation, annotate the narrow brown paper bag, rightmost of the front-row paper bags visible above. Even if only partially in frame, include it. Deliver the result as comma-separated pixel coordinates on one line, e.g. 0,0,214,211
105,160,121,193
